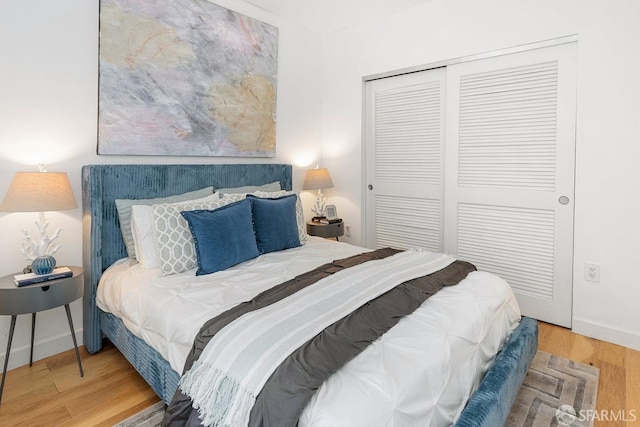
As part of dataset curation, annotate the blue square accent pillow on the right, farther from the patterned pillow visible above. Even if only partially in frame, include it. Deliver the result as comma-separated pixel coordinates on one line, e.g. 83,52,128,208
247,194,300,254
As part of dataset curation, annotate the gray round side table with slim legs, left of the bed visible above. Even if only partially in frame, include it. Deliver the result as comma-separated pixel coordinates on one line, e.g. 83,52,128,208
0,267,84,402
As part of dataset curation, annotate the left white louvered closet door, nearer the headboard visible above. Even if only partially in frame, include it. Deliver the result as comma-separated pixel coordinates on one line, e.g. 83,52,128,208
364,69,445,251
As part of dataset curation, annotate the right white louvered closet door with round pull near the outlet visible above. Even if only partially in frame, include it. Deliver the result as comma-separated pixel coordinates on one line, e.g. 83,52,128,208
444,43,576,327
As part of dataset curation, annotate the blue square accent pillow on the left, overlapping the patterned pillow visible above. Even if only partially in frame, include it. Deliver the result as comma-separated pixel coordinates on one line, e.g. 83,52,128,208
180,200,260,276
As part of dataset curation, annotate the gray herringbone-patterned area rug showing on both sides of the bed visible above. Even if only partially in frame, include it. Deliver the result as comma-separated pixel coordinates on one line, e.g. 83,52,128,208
116,350,600,427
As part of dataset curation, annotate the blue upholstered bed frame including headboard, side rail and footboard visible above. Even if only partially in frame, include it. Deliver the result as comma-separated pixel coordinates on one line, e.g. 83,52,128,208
82,164,538,427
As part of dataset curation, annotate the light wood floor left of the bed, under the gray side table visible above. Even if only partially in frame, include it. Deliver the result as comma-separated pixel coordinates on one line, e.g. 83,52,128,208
0,343,160,427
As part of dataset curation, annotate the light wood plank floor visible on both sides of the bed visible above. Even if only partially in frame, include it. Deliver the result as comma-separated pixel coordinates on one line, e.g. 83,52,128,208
0,323,640,427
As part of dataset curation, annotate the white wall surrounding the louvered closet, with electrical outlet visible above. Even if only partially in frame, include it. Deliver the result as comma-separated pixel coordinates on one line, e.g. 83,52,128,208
323,0,640,349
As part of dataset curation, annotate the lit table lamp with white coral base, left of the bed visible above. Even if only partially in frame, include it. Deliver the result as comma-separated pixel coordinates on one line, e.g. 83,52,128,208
0,171,78,275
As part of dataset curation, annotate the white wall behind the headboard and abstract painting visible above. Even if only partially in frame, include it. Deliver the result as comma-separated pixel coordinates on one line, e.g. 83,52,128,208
0,0,322,367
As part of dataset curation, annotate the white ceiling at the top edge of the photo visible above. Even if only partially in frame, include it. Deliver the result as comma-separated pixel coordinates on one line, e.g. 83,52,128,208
245,0,429,33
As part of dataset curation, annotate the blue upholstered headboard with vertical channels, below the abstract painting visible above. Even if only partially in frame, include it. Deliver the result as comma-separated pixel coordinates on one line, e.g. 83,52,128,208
82,164,292,353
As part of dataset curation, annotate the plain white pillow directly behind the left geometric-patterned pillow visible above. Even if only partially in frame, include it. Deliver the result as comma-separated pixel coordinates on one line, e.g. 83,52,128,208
131,193,220,269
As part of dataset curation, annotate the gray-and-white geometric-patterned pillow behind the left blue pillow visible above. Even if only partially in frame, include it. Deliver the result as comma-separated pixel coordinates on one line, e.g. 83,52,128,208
151,198,232,276
